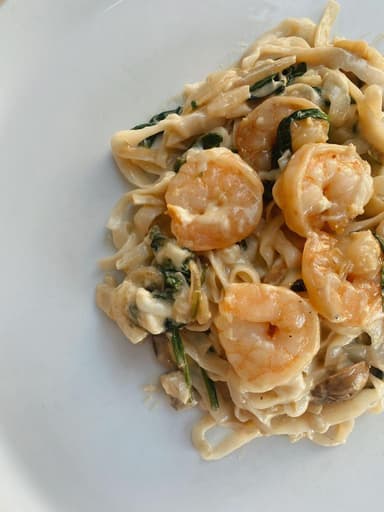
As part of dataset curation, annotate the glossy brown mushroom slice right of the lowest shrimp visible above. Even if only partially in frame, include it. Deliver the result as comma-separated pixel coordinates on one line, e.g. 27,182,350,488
312,361,369,403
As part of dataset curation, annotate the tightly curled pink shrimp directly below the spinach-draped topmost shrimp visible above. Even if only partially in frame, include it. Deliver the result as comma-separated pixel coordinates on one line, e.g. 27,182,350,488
272,144,373,236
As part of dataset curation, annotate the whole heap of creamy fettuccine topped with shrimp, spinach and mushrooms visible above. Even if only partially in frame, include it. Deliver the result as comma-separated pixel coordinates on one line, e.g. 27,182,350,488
97,1,384,459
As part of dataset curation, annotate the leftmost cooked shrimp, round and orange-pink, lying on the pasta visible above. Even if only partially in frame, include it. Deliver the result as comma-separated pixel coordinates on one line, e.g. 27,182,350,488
165,148,264,251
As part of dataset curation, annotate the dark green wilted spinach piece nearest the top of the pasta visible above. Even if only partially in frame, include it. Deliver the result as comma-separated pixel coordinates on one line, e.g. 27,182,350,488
249,62,307,99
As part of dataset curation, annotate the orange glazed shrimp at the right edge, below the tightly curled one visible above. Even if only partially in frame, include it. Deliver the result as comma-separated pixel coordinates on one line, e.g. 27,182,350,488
302,231,382,327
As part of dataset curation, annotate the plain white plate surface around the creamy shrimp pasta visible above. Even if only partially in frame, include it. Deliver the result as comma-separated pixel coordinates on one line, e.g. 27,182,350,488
0,0,384,512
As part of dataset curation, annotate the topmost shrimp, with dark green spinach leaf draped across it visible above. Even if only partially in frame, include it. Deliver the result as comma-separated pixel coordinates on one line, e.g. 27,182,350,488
235,96,328,171
